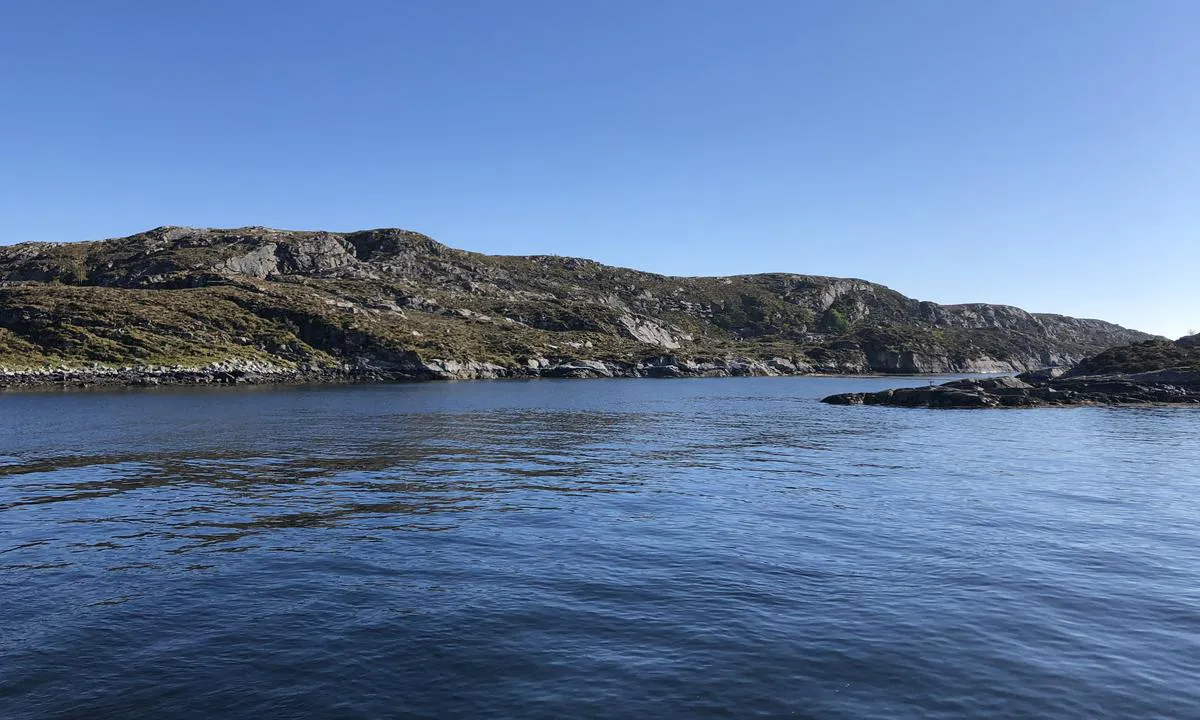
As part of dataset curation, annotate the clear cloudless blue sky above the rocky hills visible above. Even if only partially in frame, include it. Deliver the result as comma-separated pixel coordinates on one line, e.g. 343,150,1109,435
0,0,1200,336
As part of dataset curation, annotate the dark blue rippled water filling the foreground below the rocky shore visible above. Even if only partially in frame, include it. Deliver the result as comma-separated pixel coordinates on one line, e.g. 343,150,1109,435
0,378,1200,720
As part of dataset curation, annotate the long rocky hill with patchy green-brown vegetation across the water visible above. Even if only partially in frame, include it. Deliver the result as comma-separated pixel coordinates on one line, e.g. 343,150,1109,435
0,227,1151,384
